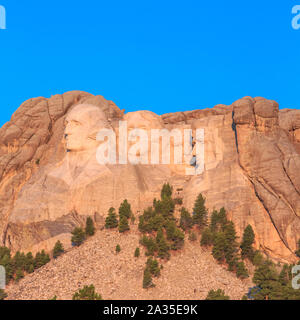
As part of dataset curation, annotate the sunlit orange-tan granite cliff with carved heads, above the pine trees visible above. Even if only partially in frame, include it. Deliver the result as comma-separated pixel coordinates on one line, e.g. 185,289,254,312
0,91,300,262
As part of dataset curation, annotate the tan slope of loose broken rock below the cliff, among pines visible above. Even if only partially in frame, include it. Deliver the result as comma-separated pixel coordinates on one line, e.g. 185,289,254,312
6,226,252,300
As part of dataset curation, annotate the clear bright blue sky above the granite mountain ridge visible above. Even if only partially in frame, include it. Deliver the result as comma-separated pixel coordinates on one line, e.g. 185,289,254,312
0,0,300,125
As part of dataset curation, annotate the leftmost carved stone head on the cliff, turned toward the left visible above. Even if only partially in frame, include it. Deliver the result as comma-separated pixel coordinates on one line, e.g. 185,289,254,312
64,104,109,152
